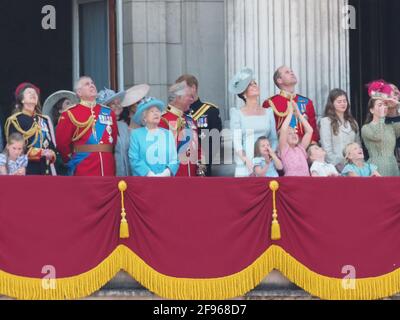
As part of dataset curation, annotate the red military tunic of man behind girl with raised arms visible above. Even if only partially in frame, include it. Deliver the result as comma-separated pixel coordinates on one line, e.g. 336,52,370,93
263,91,319,142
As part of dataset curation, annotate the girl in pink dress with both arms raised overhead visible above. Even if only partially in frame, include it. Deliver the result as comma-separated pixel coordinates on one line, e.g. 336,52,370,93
279,103,313,177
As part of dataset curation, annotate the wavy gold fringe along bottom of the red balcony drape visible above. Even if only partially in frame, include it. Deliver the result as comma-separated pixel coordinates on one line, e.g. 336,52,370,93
0,245,400,300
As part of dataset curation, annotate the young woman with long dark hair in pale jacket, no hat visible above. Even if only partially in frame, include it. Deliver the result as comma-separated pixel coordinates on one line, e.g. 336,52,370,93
320,89,361,171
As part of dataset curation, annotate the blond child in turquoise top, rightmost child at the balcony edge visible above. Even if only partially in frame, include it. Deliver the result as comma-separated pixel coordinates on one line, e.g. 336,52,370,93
342,143,381,177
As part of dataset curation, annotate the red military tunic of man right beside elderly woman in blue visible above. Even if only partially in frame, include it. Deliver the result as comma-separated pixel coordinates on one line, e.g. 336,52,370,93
160,105,201,177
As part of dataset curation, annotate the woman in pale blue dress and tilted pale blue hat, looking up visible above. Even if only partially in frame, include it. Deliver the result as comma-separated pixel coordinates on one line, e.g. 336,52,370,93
229,68,278,177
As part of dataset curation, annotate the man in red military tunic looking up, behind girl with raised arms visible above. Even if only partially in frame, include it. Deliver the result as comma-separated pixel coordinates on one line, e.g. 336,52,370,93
263,66,319,143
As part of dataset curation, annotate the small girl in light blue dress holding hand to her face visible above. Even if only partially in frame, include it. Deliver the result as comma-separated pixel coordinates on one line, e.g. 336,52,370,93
253,137,283,178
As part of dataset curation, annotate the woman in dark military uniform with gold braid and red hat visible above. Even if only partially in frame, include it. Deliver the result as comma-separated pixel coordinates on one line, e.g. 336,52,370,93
5,83,56,175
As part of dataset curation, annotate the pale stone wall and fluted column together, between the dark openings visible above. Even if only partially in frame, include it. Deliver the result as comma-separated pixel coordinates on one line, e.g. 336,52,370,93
123,0,350,125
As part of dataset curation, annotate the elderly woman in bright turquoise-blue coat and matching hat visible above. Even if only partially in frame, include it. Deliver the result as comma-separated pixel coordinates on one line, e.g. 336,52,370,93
128,98,179,177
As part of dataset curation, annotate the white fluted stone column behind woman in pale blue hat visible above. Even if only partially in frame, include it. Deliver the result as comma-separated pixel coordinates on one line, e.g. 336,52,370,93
225,0,350,116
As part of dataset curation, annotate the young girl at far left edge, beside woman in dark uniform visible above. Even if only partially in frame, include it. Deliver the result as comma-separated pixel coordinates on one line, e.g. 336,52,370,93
0,132,28,176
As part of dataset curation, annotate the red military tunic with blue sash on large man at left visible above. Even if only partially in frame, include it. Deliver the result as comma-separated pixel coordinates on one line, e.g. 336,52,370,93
56,101,118,176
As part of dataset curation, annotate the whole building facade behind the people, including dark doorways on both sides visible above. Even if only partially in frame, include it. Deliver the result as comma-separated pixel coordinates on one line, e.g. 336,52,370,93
0,0,400,135
